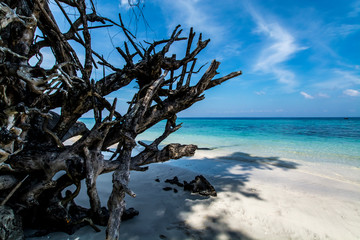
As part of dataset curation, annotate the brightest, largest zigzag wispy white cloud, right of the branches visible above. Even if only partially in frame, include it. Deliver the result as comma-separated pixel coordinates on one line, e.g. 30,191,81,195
249,3,305,91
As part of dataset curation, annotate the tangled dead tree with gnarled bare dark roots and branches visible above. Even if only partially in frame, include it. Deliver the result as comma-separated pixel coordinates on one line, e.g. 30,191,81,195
0,0,241,239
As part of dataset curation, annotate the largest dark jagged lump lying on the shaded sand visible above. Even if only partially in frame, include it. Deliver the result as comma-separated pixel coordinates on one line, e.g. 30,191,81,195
184,175,217,197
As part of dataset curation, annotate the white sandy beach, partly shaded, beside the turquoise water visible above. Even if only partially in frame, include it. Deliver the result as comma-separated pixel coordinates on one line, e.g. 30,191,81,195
26,151,360,240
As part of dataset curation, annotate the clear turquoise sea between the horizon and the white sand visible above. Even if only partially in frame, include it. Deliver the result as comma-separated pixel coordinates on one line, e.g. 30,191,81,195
82,118,360,168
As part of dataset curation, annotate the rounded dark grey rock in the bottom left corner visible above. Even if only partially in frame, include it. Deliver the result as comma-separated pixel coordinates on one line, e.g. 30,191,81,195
0,206,24,240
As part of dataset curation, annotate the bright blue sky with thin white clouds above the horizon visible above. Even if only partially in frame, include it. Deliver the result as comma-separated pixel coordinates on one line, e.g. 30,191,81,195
46,0,360,117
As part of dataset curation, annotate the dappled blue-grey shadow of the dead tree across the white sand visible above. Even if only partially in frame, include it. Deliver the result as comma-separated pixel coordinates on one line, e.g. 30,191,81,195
24,150,299,240
